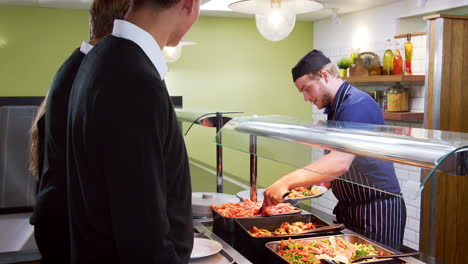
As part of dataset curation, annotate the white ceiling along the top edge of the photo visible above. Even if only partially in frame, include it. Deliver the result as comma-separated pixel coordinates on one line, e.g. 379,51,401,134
0,0,401,21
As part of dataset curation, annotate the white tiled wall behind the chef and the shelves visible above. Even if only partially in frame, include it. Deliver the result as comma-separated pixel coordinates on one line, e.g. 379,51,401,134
311,3,427,250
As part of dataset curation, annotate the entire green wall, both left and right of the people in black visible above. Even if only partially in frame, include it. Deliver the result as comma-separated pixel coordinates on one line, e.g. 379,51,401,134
0,7,313,195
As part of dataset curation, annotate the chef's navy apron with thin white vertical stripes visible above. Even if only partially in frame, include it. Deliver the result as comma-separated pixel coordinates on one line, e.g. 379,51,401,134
328,82,406,250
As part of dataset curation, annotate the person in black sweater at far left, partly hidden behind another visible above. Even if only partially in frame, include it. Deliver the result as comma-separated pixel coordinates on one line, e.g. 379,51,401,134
30,0,130,264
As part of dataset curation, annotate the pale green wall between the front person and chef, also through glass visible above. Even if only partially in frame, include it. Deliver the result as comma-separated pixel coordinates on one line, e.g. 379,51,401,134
167,17,313,194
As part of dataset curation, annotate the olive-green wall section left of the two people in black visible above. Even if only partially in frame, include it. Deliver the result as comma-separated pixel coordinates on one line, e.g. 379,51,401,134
0,6,89,96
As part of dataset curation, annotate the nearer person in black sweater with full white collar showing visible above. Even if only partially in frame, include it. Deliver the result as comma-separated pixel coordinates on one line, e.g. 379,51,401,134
67,0,200,264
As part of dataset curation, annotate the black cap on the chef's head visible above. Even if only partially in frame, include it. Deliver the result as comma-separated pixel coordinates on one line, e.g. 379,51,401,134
291,50,331,81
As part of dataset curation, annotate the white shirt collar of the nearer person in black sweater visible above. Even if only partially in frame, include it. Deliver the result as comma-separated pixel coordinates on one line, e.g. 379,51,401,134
112,19,168,80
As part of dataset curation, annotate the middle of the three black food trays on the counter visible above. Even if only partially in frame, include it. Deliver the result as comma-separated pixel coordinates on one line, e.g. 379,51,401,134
235,214,340,263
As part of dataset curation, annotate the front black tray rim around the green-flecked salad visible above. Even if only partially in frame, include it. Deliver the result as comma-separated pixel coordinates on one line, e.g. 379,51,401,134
265,234,397,264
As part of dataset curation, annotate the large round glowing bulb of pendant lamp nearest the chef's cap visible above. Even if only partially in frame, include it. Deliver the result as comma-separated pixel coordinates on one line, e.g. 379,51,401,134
255,7,296,41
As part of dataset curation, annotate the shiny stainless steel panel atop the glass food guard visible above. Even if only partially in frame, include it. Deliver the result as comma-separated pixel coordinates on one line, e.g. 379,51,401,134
221,116,468,175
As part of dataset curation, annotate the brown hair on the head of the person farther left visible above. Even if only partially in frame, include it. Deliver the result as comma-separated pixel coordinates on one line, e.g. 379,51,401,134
89,0,130,41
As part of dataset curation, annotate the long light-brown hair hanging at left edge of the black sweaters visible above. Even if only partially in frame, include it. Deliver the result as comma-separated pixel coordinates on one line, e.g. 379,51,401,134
29,96,47,180
